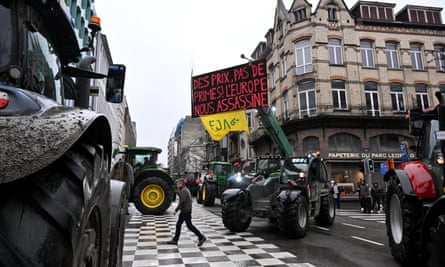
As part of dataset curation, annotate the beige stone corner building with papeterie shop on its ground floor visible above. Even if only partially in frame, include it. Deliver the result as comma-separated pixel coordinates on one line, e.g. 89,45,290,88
245,0,445,187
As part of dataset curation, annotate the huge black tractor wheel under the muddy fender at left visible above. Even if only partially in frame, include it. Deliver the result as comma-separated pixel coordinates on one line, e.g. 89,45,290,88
0,144,115,267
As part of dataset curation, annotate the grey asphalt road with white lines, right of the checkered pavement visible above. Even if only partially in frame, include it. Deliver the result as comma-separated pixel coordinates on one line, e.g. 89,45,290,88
205,200,400,267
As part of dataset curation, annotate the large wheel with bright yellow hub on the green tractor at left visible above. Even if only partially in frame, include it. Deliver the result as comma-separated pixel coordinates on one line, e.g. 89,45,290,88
133,177,174,215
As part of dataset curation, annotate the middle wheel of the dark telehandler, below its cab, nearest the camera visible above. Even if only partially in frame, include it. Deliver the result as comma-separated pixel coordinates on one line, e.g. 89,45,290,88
278,195,309,238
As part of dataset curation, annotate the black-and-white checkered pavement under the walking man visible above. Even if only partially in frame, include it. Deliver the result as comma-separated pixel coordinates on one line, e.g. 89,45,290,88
123,202,314,267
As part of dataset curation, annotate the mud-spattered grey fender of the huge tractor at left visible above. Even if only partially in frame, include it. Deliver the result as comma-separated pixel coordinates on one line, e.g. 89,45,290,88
0,88,106,183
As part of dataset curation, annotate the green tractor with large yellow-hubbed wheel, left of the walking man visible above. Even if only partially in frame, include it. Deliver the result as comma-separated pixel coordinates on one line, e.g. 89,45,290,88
114,146,176,215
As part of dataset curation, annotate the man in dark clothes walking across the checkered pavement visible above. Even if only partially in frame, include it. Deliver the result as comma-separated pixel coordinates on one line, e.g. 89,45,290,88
167,179,207,247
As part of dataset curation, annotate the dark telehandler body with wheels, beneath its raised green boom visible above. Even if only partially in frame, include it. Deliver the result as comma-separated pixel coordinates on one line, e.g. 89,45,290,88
221,153,335,238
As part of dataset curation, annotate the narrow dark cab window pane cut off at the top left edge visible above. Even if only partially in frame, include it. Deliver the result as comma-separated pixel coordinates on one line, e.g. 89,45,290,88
0,2,12,70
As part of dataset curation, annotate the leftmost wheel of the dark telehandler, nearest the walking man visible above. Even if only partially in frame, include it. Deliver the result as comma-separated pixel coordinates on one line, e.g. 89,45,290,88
222,199,252,232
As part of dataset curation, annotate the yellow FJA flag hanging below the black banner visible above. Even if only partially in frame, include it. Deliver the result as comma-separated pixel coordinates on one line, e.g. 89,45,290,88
200,109,249,141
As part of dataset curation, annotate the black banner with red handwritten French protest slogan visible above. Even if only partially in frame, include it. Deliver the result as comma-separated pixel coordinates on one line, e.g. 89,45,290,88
192,60,268,117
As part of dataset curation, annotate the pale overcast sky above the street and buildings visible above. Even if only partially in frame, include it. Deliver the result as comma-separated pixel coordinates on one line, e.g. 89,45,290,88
95,0,445,166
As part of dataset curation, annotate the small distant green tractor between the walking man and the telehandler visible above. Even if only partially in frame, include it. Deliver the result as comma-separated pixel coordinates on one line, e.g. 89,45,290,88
196,161,233,206
